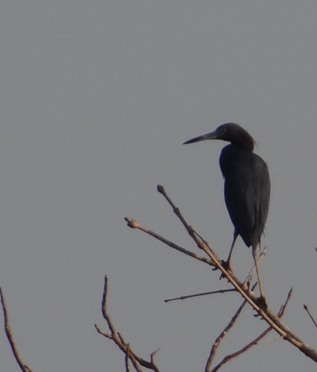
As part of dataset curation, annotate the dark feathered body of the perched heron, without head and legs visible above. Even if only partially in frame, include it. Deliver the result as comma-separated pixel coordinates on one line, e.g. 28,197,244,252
219,144,270,249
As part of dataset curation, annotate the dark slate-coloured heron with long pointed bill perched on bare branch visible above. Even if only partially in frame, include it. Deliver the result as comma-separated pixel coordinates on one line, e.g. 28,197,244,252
184,123,271,298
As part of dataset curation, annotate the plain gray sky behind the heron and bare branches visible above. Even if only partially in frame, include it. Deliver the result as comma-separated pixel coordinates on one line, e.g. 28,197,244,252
0,0,317,372
